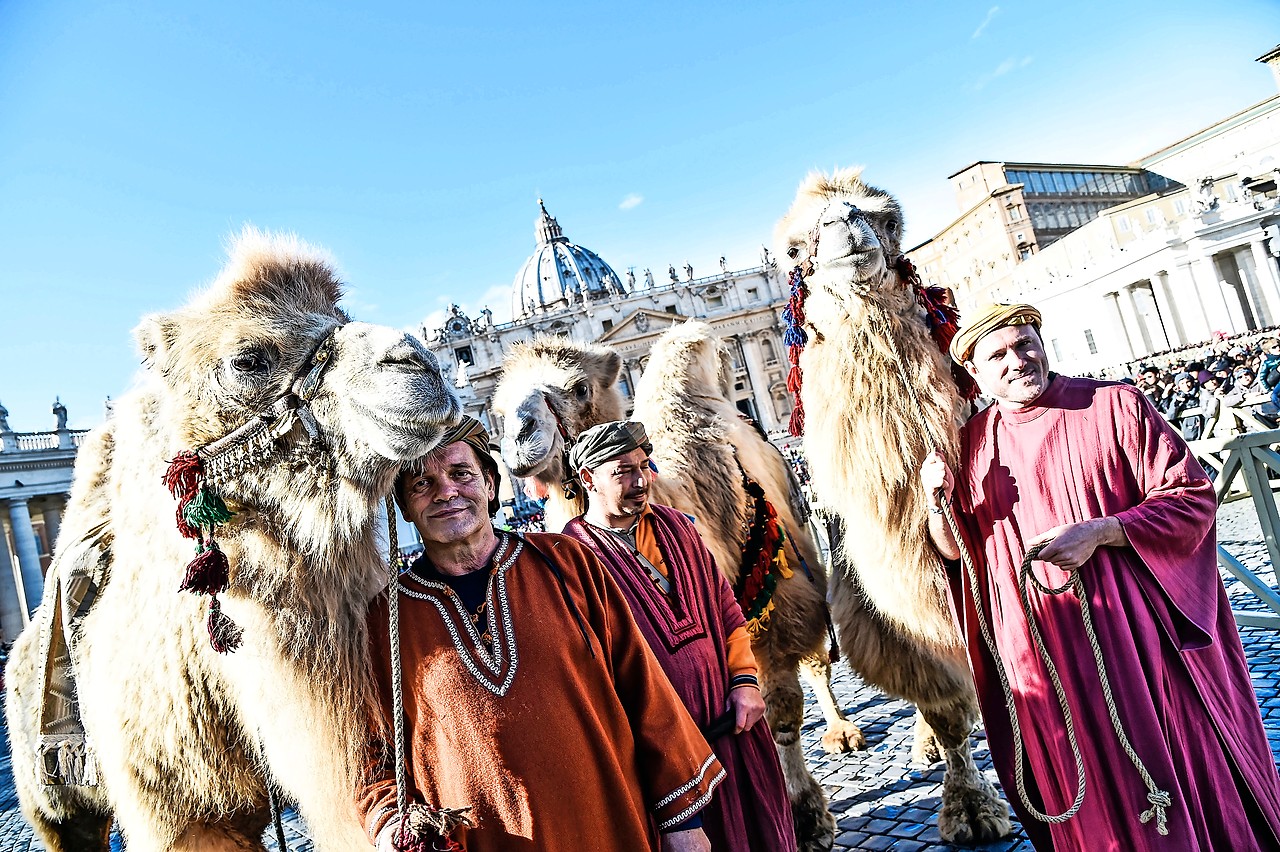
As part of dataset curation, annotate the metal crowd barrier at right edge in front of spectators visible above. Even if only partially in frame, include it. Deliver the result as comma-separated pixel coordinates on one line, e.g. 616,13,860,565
1190,408,1280,629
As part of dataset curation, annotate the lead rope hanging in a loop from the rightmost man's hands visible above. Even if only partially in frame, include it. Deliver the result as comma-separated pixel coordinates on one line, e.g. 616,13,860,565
868,302,1172,835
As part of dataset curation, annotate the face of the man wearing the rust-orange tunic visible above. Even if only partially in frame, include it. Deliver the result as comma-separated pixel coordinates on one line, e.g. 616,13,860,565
404,441,495,550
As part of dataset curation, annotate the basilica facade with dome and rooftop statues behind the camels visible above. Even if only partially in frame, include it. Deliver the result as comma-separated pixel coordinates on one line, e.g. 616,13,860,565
424,201,792,516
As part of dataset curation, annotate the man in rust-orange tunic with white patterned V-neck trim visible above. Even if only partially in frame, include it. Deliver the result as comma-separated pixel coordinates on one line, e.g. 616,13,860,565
356,418,724,852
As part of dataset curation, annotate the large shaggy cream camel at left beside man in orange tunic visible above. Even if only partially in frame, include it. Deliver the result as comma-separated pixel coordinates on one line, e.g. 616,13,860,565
8,230,460,852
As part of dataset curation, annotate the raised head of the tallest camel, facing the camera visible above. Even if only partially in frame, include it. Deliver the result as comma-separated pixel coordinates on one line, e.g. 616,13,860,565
774,169,902,305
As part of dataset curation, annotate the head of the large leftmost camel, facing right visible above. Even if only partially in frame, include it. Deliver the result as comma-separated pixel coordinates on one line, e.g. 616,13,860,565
134,223,461,535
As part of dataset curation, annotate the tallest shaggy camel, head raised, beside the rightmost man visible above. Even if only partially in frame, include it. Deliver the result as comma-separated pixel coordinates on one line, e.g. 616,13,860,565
777,170,1011,842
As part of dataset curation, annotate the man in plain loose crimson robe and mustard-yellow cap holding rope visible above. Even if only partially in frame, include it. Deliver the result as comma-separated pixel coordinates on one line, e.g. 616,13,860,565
920,304,1280,852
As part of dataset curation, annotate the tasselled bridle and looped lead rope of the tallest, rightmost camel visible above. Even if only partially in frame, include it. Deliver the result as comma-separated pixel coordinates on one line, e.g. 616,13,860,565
782,205,1172,835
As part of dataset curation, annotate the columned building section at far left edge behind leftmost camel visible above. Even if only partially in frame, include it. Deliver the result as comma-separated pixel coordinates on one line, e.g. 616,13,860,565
0,402,87,645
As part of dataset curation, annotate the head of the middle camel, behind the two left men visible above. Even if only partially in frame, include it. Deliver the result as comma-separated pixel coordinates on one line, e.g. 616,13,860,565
493,338,623,486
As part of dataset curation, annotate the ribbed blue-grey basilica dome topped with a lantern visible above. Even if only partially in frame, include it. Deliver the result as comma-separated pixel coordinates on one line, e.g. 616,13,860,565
511,198,627,320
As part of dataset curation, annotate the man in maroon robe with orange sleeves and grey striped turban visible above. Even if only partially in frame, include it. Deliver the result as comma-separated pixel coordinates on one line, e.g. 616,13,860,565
564,421,796,852
